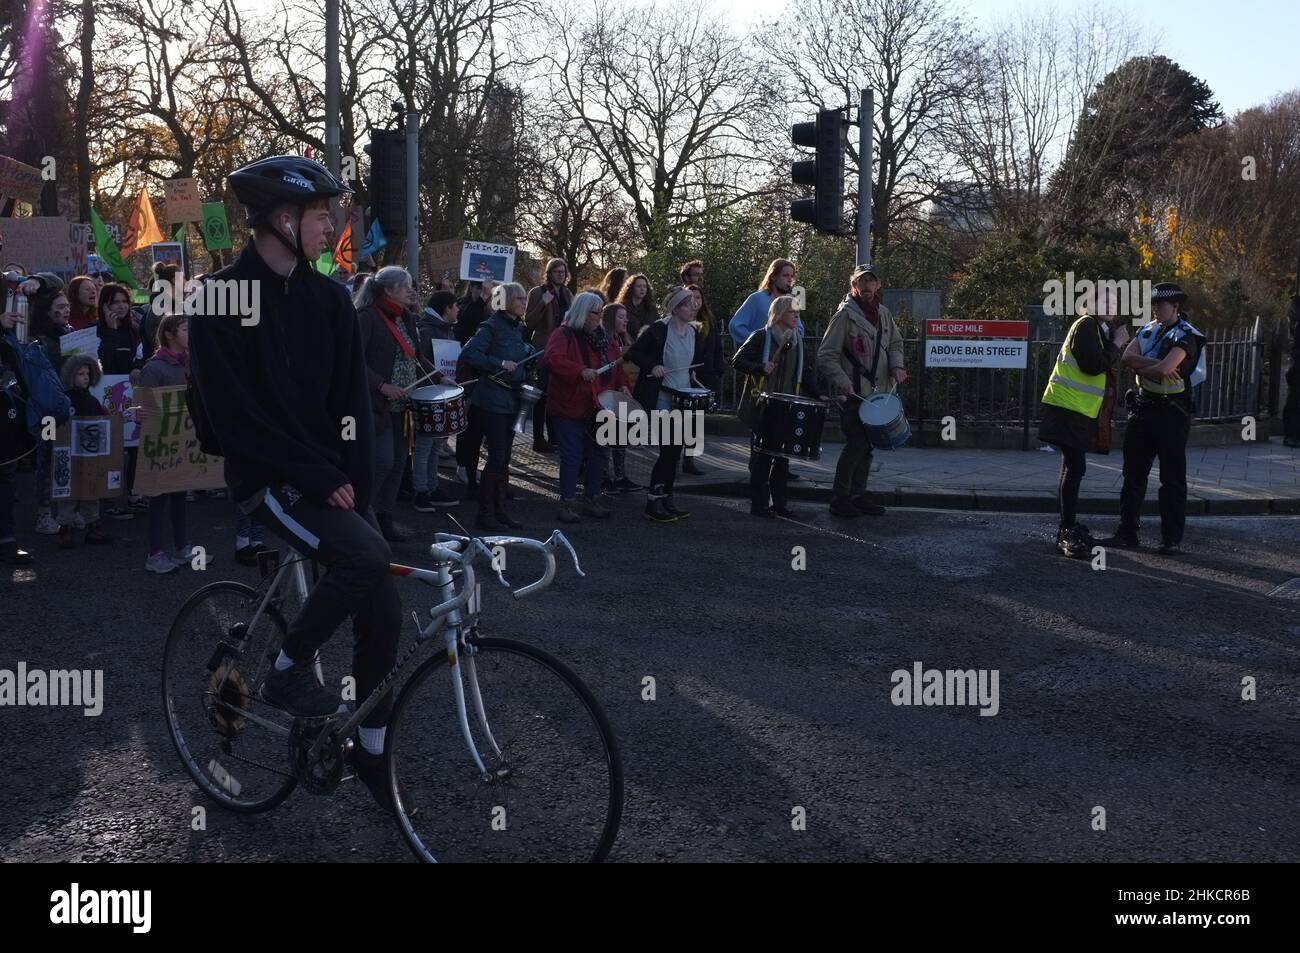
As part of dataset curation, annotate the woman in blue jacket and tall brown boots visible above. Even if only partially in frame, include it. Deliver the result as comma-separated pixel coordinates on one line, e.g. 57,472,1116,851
460,282,534,529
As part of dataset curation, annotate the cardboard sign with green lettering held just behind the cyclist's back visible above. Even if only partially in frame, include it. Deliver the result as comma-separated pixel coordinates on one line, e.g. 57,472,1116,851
131,385,226,497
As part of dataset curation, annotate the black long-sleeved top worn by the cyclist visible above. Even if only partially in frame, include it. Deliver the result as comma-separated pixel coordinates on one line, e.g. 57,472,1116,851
189,239,374,514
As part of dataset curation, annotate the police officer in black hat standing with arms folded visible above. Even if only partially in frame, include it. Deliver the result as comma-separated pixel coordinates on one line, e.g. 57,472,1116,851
1102,282,1205,555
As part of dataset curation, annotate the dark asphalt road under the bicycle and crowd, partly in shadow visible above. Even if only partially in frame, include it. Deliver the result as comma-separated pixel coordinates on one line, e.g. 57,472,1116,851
0,483,1300,862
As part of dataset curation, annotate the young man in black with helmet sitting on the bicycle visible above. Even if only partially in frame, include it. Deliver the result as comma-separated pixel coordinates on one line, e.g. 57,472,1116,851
190,156,402,811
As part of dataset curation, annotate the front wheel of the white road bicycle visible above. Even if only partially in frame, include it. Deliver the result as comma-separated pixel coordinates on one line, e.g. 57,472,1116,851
387,637,623,863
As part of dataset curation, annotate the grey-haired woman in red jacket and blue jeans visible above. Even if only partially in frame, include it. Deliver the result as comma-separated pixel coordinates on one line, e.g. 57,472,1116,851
542,291,629,523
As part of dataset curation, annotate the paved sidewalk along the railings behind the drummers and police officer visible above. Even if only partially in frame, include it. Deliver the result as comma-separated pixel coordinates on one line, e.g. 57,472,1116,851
515,434,1300,515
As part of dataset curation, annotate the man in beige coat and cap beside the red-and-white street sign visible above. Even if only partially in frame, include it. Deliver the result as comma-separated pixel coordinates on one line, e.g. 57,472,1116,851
816,265,907,516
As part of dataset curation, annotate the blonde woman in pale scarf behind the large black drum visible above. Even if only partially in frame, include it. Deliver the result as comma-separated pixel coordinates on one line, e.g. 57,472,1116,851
732,295,822,517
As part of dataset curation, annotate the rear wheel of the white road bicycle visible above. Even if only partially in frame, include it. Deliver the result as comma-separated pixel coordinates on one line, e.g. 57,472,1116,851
163,581,296,814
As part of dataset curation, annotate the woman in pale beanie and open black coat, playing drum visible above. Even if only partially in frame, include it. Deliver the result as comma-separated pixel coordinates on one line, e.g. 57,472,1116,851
625,285,705,523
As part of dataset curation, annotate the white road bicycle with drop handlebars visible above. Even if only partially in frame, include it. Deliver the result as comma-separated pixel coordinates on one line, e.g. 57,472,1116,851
163,529,623,862
